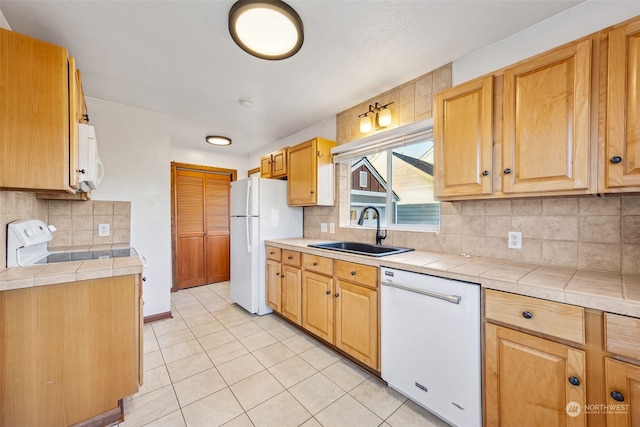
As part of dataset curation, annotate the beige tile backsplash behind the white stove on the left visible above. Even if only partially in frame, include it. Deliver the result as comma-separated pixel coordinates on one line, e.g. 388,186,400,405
0,191,131,270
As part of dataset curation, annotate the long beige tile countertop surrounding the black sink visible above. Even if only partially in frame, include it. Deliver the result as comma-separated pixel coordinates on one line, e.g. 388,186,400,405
265,238,640,317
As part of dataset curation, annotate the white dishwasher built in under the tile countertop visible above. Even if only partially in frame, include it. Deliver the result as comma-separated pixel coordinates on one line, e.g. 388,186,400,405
380,267,482,427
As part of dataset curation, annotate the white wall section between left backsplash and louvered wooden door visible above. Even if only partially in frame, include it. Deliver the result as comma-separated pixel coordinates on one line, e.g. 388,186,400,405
86,97,171,316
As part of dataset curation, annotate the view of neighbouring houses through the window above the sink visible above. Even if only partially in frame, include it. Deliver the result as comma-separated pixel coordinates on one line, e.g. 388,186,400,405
349,138,440,229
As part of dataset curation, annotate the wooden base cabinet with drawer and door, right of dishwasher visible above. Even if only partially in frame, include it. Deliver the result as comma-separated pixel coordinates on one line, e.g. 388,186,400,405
484,290,587,427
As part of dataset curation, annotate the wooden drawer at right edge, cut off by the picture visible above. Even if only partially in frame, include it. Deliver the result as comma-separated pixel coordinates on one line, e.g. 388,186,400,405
604,313,640,360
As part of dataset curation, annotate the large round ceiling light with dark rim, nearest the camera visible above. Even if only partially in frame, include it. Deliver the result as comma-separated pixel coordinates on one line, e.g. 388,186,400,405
229,0,304,60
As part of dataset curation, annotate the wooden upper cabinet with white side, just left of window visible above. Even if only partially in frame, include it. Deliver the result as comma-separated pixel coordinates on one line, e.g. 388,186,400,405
287,137,336,206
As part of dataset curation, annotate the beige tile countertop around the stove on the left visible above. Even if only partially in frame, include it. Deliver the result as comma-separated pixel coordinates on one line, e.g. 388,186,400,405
0,245,143,291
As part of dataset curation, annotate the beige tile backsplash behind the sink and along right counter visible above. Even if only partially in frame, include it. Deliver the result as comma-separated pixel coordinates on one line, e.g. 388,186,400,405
304,168,640,274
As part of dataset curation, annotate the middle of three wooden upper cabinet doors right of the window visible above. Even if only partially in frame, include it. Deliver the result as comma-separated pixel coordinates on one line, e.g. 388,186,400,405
503,40,591,193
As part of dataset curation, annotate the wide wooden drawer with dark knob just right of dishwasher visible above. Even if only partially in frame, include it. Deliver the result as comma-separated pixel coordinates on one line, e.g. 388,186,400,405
485,289,585,344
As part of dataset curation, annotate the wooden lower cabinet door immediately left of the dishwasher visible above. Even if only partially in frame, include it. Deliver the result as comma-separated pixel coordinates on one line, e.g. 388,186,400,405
335,280,380,370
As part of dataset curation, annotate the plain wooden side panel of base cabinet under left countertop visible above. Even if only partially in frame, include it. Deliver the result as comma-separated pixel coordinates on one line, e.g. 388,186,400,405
0,275,143,426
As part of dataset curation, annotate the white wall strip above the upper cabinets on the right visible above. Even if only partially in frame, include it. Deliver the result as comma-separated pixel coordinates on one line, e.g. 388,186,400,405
452,0,640,86
